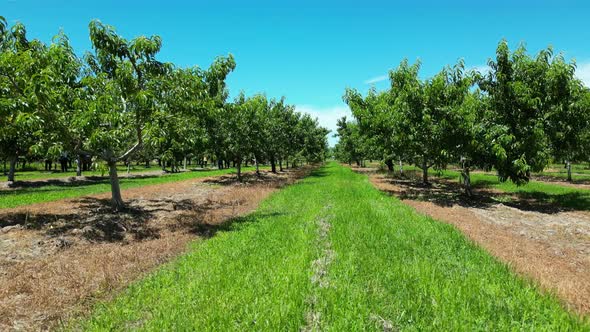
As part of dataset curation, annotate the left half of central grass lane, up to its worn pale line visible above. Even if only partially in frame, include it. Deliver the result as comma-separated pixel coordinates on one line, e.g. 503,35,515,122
74,166,330,331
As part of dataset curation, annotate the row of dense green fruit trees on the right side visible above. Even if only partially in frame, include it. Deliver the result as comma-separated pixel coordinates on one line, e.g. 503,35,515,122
335,41,590,193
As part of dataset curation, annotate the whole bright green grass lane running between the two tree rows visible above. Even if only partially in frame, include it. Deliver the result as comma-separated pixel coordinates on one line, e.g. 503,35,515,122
74,163,590,331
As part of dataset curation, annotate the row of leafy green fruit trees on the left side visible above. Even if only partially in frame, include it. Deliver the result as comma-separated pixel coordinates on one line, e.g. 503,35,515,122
0,17,328,208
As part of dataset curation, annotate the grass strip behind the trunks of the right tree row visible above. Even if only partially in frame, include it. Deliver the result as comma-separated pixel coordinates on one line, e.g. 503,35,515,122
442,170,590,210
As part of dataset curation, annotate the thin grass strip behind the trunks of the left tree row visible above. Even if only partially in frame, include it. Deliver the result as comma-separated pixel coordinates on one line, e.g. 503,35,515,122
0,167,254,209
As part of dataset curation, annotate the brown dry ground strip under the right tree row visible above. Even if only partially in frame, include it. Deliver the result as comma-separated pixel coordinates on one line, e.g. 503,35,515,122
355,169,590,316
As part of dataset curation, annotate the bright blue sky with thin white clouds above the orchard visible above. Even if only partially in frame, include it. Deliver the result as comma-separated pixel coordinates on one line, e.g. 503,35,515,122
0,0,590,143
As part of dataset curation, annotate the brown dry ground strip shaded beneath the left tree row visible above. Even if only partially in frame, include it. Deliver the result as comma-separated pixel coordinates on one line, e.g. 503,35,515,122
0,167,311,331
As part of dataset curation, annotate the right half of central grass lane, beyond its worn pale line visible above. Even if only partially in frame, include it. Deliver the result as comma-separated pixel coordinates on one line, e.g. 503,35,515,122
321,166,589,331
